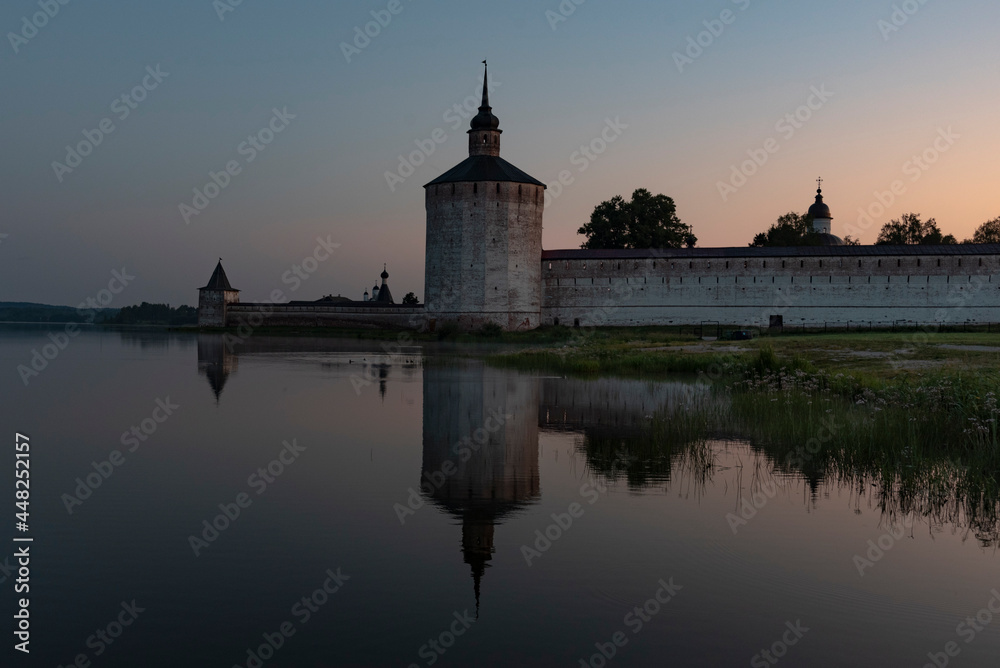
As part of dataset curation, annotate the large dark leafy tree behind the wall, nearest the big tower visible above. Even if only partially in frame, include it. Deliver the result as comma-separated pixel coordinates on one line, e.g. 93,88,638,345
578,188,698,249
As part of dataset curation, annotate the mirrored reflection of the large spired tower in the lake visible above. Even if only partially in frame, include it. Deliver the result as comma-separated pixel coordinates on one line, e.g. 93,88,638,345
421,365,539,615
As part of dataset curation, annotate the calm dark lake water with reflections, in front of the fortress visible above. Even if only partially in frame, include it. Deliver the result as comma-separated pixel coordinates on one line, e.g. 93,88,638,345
0,326,1000,668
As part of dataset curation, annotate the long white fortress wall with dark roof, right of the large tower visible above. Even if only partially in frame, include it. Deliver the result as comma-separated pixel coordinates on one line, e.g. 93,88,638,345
542,245,1000,327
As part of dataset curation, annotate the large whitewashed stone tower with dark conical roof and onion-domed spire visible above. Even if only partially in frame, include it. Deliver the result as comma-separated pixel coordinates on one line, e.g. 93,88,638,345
424,61,545,331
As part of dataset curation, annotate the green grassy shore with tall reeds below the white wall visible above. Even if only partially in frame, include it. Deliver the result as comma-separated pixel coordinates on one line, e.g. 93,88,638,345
528,332,1000,545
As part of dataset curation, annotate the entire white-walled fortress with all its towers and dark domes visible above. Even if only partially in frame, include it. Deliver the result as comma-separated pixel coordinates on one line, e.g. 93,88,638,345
198,64,1000,331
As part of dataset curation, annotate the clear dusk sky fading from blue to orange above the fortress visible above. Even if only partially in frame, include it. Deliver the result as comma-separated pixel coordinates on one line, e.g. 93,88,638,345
0,0,1000,307
